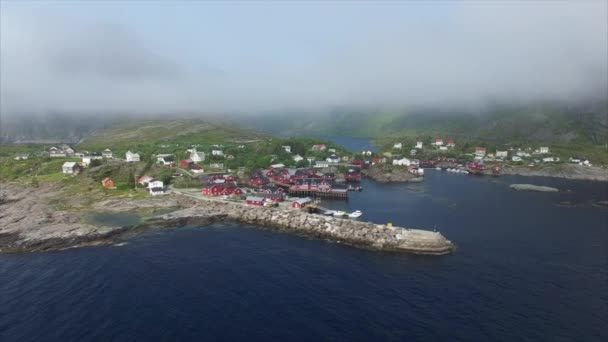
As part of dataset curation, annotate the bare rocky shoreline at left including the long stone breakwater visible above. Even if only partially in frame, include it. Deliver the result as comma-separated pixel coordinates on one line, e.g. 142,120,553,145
0,186,455,255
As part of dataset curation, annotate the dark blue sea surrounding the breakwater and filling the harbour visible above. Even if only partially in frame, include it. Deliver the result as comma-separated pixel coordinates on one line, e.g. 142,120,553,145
0,140,608,342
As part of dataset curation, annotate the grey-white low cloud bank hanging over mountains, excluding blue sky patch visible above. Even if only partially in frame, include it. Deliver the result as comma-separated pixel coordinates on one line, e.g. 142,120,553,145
0,1,608,116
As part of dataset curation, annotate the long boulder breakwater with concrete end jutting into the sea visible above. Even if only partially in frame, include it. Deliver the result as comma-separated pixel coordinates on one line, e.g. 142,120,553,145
159,201,454,255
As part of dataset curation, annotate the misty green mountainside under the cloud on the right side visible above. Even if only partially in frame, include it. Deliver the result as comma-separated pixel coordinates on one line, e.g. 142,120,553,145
243,103,608,145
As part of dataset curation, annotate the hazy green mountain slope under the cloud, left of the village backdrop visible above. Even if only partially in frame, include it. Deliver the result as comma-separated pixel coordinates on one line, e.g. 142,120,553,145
0,114,264,148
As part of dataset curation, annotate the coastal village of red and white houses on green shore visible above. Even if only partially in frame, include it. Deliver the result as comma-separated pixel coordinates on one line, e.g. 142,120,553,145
4,138,591,218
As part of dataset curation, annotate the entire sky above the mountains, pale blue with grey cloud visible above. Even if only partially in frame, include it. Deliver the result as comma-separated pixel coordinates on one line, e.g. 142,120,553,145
0,0,608,116
